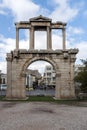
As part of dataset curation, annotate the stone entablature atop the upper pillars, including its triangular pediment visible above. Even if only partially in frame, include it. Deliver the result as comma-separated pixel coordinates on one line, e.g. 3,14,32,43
15,15,66,29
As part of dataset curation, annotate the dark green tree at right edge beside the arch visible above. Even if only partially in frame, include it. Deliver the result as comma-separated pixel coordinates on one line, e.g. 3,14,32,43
75,59,87,93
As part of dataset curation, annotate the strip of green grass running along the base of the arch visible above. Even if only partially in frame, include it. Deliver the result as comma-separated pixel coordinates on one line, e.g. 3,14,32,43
0,95,87,107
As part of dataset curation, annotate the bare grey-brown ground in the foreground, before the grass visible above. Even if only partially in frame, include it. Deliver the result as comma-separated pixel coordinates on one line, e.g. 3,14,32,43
0,102,87,130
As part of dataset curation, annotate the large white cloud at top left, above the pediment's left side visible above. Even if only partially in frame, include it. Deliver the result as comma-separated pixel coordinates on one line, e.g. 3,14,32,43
3,0,39,21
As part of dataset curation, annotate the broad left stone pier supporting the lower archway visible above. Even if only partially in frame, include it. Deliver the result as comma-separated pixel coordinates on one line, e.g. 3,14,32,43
6,57,26,100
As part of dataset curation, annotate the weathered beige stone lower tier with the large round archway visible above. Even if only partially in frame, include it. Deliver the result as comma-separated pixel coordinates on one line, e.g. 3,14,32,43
7,50,78,99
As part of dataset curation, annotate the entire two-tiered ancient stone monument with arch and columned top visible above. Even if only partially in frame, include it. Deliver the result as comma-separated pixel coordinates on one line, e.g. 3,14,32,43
6,15,78,99
